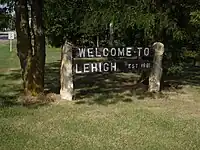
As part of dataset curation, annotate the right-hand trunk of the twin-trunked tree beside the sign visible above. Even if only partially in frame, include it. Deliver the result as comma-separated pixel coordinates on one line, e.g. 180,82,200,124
31,0,46,93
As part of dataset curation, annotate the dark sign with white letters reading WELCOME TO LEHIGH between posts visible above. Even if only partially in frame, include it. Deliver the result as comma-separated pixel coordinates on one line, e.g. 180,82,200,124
73,47,154,74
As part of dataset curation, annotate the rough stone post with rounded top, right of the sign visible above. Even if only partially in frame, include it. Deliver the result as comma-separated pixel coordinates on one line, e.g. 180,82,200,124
148,42,164,92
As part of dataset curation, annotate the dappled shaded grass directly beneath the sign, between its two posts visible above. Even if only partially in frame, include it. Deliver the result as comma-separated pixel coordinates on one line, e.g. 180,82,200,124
74,73,141,105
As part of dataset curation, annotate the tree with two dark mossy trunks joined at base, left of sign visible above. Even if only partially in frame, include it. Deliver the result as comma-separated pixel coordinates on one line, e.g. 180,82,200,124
15,0,45,95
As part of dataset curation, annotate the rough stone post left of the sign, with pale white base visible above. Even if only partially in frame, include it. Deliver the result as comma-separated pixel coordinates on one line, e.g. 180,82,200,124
60,41,74,101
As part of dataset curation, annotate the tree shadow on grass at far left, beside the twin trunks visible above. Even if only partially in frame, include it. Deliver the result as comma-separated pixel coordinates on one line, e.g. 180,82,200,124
0,69,52,108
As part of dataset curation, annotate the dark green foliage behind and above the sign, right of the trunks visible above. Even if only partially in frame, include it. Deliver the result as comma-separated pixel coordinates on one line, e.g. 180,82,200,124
45,0,200,74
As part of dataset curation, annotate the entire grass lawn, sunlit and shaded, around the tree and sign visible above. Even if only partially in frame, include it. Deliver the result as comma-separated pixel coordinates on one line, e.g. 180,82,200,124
0,40,200,150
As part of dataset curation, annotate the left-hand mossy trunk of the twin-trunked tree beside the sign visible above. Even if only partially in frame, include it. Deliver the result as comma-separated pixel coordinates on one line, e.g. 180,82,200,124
15,0,33,94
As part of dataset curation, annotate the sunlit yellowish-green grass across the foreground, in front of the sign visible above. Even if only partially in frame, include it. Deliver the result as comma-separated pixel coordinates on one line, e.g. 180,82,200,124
0,94,200,150
